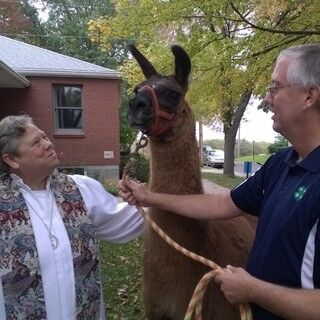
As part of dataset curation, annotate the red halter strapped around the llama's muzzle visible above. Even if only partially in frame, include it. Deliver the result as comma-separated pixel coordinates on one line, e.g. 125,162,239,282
141,86,176,136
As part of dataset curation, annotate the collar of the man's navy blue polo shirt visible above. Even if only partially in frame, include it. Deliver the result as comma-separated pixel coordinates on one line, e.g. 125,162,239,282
284,146,320,172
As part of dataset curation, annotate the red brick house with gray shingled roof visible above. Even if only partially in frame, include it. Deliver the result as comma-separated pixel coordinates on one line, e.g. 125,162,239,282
0,36,120,179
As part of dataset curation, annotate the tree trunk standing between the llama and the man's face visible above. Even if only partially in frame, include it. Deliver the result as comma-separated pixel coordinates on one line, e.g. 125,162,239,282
223,90,252,177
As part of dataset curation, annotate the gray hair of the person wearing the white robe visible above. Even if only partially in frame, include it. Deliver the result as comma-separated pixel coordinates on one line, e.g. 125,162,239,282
0,115,34,175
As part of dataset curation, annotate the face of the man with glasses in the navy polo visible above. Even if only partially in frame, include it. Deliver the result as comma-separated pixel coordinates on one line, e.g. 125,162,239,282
265,58,306,137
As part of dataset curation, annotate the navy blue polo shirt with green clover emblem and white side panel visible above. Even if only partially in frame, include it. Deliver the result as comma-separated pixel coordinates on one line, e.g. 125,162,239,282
231,146,320,320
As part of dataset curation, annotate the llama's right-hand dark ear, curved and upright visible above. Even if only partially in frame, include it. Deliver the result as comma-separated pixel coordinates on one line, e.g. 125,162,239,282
171,45,191,89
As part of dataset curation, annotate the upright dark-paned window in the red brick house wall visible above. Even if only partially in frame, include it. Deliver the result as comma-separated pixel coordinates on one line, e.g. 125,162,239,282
54,85,83,130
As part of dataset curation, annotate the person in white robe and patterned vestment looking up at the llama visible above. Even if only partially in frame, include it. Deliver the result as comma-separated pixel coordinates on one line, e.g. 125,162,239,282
0,116,144,320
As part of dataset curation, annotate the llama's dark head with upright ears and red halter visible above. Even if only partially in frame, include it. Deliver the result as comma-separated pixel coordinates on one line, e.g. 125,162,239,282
127,45,191,138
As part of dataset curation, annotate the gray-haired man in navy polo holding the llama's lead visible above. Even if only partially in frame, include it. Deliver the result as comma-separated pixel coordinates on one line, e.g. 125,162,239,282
120,44,320,320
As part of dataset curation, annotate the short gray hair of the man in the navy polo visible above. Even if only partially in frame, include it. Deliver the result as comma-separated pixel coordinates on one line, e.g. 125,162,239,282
277,44,320,89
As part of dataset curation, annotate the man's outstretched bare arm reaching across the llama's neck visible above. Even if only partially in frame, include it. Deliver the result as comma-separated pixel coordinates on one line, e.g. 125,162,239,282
119,178,244,220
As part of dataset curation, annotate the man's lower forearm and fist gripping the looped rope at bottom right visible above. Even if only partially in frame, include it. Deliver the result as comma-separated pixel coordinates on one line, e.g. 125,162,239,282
215,266,320,320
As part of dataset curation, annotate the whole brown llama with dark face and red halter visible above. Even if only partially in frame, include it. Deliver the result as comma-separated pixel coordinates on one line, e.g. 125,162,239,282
128,45,254,320
